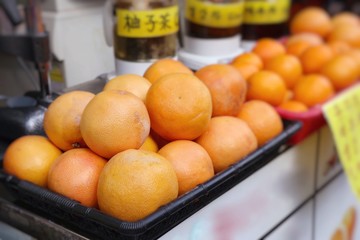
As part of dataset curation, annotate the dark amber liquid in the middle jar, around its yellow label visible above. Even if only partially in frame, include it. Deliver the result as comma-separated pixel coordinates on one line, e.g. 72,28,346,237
185,0,242,39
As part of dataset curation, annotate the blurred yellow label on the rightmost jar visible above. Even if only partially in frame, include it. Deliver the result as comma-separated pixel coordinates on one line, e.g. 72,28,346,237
244,0,290,24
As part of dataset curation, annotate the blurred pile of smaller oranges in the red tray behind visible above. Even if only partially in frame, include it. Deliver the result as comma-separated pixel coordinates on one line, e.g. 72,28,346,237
231,7,360,112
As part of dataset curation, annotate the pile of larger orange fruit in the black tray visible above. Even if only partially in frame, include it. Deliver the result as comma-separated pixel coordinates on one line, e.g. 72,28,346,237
3,59,283,221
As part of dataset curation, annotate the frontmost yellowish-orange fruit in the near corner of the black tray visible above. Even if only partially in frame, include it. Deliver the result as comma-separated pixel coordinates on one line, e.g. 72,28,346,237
97,149,178,222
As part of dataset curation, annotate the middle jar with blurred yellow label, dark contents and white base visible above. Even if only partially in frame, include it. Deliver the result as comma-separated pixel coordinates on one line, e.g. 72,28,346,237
179,0,244,69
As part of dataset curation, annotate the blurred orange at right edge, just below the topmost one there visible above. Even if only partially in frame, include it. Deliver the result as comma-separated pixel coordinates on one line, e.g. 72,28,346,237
327,25,360,48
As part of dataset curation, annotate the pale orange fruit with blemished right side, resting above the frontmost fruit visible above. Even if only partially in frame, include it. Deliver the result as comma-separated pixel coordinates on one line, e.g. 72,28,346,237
80,90,150,158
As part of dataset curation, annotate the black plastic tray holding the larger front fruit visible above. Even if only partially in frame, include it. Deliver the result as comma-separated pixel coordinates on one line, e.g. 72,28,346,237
0,121,302,240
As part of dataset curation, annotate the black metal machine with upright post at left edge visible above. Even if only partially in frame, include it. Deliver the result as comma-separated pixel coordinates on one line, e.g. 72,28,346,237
0,0,52,140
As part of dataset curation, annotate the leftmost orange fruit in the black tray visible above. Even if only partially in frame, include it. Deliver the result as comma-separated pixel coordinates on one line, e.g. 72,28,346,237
3,135,62,187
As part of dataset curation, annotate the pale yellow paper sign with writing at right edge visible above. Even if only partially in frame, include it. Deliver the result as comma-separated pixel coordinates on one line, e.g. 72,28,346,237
323,84,360,200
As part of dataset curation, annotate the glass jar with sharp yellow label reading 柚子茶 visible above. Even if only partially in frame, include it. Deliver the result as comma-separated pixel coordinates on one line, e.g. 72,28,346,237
113,0,179,74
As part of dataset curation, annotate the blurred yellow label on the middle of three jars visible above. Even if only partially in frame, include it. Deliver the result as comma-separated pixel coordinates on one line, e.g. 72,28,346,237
185,0,244,28
